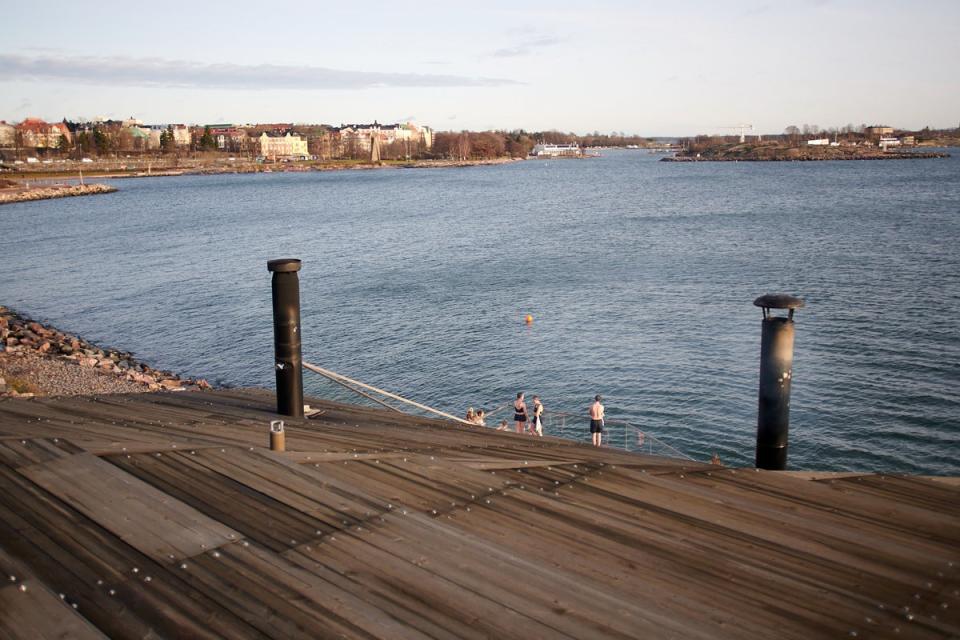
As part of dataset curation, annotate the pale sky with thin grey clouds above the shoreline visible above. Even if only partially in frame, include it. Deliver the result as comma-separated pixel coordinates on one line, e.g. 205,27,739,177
0,0,960,136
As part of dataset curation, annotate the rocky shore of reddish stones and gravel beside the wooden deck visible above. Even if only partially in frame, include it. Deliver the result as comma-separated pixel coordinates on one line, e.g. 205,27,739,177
0,306,211,398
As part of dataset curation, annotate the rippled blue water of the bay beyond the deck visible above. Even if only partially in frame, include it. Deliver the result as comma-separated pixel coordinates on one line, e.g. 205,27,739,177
0,151,960,474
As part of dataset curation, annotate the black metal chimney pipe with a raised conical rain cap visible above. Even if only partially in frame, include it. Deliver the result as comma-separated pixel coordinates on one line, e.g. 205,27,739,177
753,294,803,471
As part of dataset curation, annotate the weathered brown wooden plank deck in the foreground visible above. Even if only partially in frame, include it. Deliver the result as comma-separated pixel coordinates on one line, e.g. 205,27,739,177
0,390,960,640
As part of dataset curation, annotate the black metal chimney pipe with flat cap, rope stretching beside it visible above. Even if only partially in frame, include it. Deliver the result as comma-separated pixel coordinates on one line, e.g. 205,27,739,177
267,258,303,418
